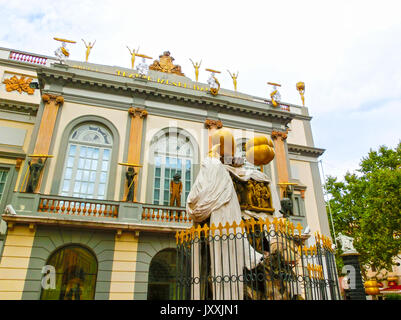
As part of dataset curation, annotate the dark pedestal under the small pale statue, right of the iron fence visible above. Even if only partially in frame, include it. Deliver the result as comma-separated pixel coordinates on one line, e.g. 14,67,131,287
341,253,366,300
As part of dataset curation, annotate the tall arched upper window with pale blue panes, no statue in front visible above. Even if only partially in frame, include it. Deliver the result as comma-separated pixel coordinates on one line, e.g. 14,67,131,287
60,123,113,199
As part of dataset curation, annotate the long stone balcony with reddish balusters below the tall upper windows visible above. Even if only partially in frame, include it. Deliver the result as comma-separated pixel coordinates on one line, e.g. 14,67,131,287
6,192,192,232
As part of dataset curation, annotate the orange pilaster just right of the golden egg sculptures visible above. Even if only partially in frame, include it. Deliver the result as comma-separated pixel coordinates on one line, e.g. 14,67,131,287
271,130,289,199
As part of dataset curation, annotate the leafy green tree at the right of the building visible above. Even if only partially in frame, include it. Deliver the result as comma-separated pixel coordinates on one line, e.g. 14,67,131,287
325,142,401,275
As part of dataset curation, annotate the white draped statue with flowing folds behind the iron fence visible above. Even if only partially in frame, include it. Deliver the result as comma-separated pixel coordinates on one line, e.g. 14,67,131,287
186,156,263,300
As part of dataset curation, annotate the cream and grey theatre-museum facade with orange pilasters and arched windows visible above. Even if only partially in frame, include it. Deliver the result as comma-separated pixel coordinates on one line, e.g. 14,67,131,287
0,48,330,300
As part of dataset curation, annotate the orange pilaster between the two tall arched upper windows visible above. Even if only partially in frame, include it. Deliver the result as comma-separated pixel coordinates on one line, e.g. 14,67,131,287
123,107,148,202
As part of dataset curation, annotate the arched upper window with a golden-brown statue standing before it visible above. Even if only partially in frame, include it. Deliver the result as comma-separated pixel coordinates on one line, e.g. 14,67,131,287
152,129,195,206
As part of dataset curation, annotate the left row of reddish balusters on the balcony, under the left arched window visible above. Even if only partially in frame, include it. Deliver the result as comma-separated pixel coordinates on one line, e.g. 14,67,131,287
38,196,119,218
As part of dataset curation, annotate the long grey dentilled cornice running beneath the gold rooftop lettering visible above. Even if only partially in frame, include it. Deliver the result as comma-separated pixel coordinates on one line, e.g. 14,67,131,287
38,67,297,125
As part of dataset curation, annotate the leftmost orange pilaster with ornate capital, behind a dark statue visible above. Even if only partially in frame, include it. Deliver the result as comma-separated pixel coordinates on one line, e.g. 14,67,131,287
27,94,64,193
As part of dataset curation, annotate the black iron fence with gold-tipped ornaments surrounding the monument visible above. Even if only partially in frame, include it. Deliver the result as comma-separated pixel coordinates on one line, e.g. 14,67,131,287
176,218,340,300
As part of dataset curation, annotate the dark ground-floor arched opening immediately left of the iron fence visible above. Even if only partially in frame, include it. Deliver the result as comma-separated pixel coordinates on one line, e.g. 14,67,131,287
148,249,177,300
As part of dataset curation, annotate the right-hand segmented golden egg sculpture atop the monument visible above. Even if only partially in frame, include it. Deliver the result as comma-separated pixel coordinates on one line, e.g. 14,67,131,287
245,136,275,166
